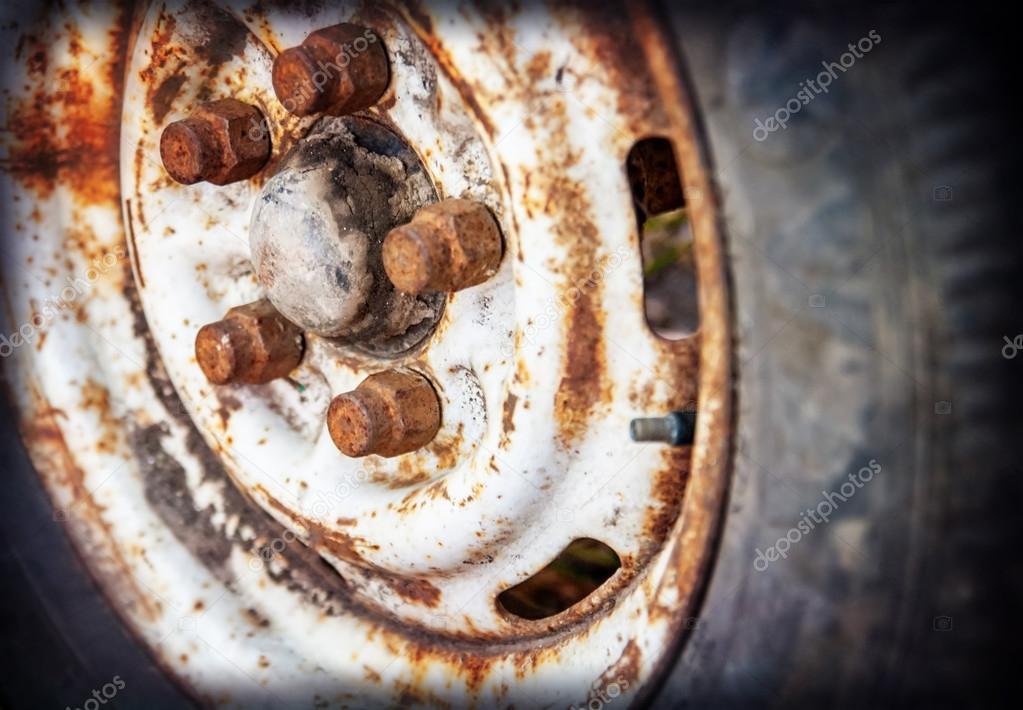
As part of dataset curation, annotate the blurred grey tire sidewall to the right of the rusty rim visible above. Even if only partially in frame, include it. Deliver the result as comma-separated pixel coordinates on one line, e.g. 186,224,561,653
652,3,1023,708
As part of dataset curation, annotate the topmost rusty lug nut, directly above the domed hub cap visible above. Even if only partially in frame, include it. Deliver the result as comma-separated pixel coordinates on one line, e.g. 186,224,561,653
272,23,390,116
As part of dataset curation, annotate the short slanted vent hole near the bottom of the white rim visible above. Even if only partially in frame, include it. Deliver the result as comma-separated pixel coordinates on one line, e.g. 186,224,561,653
497,537,622,621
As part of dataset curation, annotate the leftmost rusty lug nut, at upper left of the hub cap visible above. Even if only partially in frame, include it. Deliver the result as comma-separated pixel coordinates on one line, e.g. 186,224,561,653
160,98,270,185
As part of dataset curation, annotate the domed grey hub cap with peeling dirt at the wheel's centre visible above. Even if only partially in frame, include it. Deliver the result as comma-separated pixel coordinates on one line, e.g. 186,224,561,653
250,117,444,354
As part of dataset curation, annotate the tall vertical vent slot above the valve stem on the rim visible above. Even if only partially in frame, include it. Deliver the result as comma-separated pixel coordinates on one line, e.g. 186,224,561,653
626,137,700,340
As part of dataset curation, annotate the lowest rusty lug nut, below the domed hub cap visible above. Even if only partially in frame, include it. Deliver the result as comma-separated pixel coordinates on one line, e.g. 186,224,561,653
326,369,441,456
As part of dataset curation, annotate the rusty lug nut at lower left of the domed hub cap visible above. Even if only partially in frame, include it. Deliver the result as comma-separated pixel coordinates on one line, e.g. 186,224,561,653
195,299,304,385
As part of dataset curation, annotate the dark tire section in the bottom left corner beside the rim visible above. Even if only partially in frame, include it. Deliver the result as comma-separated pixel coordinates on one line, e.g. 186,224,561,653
0,396,191,708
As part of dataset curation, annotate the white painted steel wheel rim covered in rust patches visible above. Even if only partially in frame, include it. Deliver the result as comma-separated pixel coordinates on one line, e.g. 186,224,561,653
2,3,730,707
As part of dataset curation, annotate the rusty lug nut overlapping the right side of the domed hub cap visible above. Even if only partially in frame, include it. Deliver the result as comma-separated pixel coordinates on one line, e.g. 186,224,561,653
384,198,501,294
